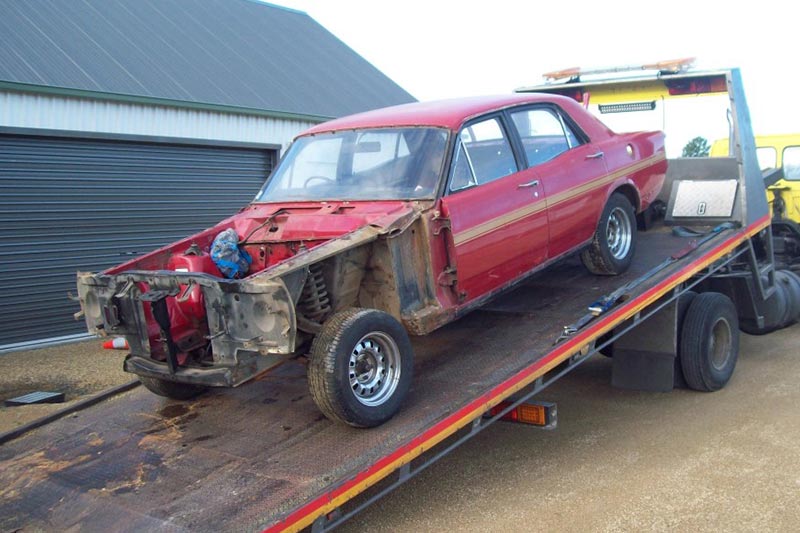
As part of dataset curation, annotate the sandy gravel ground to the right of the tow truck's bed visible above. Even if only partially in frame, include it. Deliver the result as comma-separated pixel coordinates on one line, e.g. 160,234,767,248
341,325,800,532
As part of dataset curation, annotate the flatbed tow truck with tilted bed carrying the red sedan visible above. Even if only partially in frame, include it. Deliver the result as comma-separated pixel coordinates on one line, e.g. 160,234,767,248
0,65,800,532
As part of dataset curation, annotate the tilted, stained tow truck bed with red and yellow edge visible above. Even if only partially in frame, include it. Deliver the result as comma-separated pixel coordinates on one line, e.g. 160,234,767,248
0,218,768,531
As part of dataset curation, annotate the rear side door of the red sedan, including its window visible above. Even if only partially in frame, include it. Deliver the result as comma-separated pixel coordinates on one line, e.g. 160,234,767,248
510,104,607,257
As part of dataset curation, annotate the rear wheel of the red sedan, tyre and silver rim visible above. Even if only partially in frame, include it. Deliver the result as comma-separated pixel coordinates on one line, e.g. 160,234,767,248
581,193,636,276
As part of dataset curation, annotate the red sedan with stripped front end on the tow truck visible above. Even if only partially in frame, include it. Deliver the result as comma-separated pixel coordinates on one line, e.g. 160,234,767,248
78,94,666,427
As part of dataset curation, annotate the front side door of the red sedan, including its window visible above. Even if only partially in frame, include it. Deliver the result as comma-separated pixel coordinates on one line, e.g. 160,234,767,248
441,114,547,301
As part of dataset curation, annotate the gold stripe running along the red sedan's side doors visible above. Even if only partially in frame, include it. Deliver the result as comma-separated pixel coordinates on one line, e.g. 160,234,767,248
453,153,666,246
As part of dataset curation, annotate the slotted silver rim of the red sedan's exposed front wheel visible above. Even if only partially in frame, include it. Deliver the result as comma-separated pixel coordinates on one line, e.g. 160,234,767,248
348,331,400,407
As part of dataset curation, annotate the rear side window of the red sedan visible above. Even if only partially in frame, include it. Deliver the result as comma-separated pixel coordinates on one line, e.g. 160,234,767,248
511,107,582,167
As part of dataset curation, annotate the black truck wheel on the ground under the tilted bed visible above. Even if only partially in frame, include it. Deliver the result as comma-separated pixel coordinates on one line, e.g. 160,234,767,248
679,292,739,392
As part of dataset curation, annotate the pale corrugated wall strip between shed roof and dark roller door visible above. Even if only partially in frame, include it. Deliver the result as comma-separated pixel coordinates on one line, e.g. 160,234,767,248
0,91,317,152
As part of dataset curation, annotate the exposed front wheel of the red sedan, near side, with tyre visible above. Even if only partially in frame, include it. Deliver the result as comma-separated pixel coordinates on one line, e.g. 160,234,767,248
308,309,414,427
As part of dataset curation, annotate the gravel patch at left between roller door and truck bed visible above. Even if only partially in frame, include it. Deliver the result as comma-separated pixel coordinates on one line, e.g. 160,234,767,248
0,339,134,433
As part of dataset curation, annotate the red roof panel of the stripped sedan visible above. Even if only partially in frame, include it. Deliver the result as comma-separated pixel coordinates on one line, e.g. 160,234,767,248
303,93,569,135
